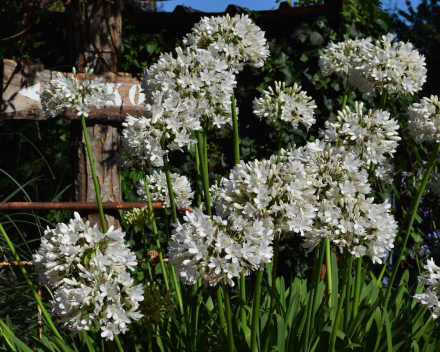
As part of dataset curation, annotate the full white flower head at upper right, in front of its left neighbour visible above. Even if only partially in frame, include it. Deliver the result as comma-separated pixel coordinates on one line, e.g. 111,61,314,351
349,33,427,94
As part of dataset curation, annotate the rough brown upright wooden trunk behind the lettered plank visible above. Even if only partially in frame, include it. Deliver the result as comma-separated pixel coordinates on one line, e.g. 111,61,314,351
66,0,122,228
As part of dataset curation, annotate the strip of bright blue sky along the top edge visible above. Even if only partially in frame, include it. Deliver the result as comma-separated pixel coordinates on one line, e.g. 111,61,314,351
159,0,420,12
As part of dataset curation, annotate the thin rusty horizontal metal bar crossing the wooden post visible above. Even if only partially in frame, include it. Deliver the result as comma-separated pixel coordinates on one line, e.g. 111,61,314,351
0,202,193,213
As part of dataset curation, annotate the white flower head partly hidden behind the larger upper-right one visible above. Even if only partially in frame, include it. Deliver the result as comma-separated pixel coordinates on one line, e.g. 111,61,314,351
319,37,372,77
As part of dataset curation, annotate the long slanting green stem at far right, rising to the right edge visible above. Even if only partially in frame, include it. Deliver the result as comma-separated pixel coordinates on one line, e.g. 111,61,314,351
374,143,440,352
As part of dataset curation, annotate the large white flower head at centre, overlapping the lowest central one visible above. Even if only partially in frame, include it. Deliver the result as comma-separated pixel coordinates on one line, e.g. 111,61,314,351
216,155,316,237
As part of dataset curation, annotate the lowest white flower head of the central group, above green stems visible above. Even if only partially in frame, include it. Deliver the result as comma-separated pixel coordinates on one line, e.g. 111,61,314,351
169,208,273,286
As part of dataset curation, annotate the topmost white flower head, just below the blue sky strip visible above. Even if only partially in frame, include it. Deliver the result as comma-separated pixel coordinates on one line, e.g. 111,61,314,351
183,14,270,72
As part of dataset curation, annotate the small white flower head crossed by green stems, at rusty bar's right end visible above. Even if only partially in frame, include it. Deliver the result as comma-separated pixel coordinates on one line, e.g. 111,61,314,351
137,171,194,208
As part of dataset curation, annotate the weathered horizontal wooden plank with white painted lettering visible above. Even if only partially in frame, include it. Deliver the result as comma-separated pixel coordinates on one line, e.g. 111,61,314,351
0,59,145,121
